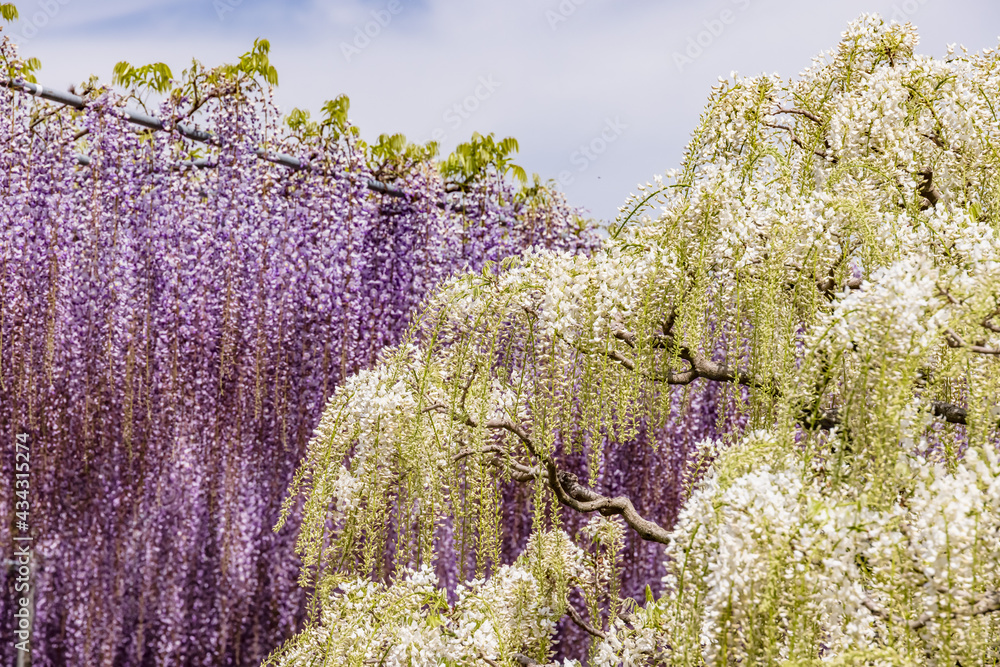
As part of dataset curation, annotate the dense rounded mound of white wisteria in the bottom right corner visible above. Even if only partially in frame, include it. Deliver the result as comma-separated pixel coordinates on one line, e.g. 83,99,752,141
596,435,1000,665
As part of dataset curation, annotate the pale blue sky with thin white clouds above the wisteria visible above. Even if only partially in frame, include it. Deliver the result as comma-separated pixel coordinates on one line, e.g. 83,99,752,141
5,0,1000,220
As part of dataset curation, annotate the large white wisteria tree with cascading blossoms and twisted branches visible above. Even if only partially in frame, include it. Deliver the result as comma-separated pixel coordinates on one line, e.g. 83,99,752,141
275,15,1000,667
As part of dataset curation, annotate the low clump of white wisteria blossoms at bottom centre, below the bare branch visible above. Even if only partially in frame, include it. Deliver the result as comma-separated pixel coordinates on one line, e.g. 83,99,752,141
265,531,588,667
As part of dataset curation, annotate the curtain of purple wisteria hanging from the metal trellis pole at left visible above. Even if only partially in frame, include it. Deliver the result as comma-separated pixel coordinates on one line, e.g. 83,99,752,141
0,22,596,667
